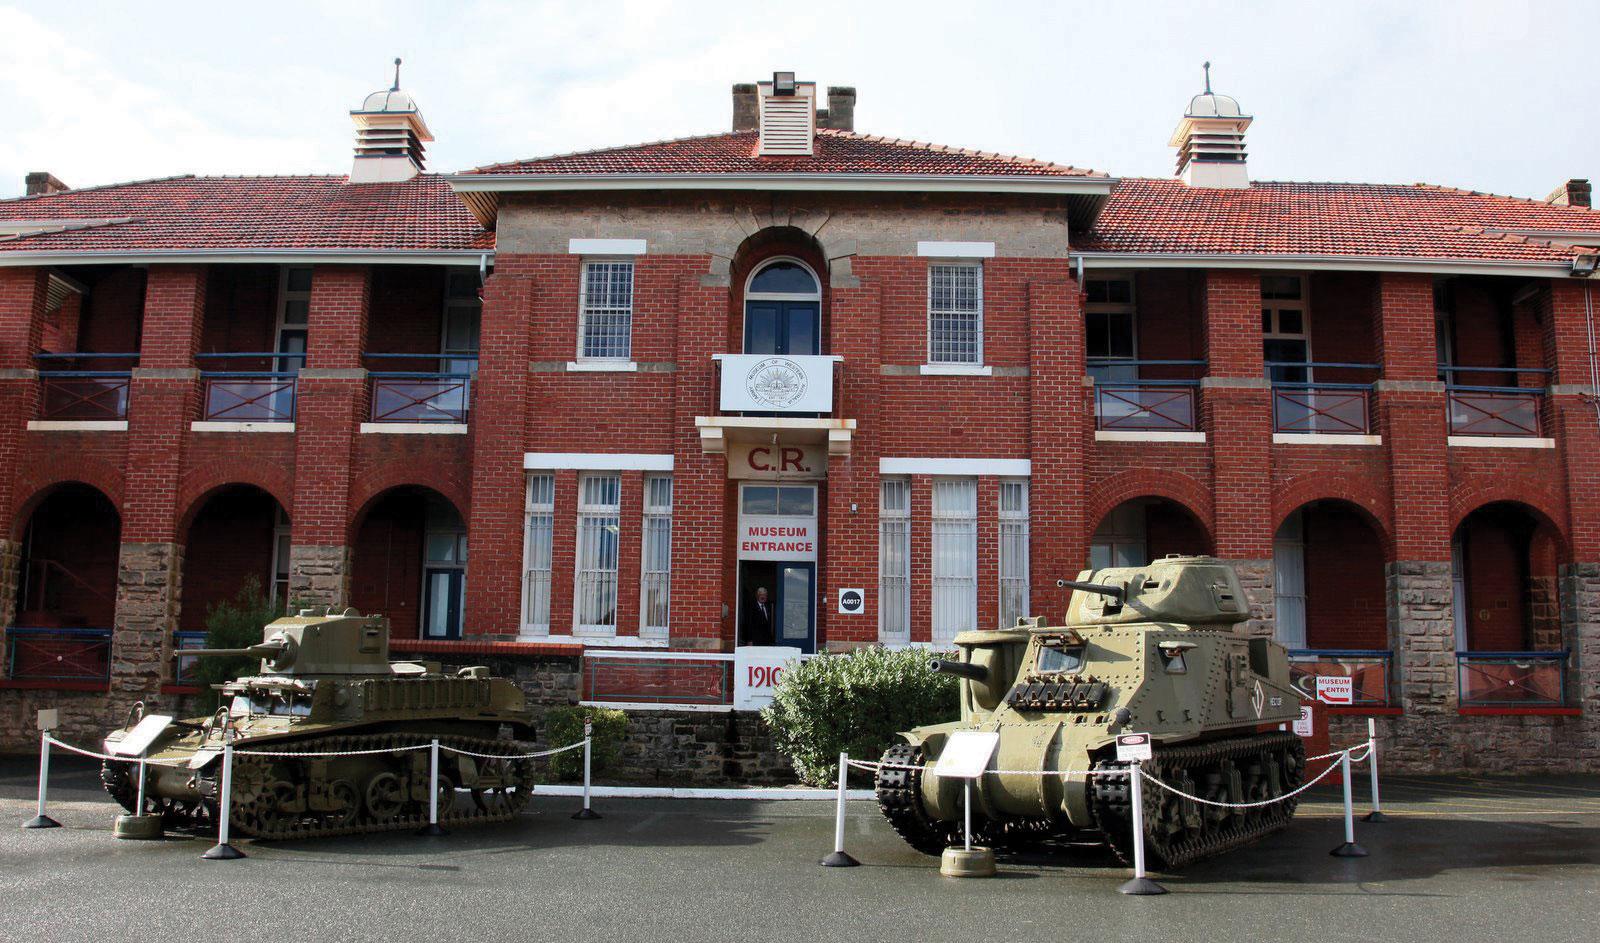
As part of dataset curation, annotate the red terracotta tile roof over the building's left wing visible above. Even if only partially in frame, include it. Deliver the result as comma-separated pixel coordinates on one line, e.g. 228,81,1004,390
0,175,494,253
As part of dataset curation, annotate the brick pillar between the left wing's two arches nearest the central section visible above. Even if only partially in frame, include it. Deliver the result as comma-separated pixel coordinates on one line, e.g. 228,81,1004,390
290,266,371,607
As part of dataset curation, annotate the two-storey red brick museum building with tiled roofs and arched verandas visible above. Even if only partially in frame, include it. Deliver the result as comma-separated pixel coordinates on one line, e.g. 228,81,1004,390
0,74,1600,767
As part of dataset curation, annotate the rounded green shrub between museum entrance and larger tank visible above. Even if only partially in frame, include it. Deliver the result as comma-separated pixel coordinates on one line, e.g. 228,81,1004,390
762,647,960,786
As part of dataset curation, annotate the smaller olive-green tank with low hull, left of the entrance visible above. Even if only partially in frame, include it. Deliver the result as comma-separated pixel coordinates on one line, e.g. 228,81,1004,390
101,610,534,839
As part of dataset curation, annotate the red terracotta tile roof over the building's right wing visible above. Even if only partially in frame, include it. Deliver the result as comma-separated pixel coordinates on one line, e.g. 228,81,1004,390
1074,178,1600,263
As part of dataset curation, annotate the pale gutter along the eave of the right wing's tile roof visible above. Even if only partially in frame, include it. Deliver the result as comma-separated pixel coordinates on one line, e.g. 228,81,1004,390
1072,251,1573,279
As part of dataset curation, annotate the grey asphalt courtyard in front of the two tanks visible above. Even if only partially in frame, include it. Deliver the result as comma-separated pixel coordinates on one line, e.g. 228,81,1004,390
0,757,1600,943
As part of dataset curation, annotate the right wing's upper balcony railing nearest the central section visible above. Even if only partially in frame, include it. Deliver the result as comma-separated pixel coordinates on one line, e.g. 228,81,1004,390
1088,357,1206,432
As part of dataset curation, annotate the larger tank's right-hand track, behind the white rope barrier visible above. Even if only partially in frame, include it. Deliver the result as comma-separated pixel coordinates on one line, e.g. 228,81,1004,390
1090,733,1306,869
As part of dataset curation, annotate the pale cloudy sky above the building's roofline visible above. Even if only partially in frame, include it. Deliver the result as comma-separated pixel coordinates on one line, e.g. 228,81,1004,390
0,0,1600,197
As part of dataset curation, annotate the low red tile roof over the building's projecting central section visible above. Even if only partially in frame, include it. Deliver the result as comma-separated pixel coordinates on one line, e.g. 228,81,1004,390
466,128,1106,176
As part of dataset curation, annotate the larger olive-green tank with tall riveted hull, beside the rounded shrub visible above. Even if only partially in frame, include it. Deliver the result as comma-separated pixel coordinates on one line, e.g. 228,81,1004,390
877,557,1306,868
